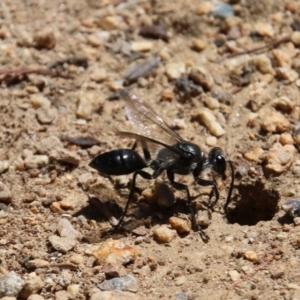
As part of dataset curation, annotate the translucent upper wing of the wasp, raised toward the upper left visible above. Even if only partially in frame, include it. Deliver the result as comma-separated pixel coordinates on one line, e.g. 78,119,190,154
118,89,183,147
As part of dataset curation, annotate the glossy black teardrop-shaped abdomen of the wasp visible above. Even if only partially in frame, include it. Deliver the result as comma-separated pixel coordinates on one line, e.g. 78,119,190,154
89,149,147,175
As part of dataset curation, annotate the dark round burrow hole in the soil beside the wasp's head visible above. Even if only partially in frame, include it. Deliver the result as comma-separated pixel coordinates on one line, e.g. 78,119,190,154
227,181,280,226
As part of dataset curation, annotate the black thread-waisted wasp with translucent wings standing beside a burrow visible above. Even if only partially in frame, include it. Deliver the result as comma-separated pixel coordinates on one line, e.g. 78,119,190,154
89,89,234,240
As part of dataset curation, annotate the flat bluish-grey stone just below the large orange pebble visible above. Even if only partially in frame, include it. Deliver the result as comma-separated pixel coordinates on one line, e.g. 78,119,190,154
98,275,138,293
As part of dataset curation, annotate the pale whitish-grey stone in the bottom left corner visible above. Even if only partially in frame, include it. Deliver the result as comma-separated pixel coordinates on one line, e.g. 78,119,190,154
0,271,25,297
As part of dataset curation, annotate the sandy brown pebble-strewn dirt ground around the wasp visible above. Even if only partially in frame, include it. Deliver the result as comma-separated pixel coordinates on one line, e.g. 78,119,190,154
0,0,300,300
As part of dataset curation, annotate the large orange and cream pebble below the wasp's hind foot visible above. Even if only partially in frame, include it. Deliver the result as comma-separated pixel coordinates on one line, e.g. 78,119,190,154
93,239,137,265
